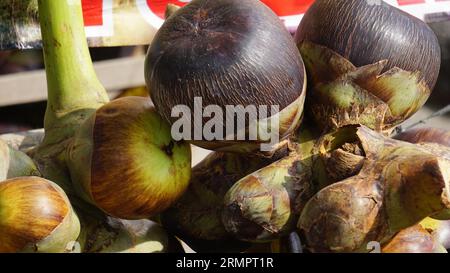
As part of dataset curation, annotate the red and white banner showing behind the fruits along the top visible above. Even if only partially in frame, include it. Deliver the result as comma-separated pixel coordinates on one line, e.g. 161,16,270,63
82,0,450,37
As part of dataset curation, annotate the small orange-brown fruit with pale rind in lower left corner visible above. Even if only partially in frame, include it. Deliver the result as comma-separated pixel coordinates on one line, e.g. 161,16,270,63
0,177,80,253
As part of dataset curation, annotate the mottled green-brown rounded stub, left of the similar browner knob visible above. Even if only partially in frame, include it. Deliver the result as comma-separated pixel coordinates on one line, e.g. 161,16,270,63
222,155,313,242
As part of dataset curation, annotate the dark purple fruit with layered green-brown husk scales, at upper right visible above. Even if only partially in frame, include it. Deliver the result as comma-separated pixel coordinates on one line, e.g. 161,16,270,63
295,0,441,133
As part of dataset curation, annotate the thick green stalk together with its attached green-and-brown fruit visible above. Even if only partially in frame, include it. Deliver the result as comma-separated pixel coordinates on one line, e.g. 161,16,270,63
35,0,191,220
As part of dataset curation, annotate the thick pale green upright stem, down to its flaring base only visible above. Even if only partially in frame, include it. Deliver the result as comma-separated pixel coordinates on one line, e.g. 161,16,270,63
38,0,108,129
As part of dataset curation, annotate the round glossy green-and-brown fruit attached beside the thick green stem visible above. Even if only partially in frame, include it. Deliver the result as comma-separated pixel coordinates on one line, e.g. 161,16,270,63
67,97,191,220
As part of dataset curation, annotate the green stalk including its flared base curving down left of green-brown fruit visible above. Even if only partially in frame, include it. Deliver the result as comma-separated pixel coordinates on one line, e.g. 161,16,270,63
35,0,109,194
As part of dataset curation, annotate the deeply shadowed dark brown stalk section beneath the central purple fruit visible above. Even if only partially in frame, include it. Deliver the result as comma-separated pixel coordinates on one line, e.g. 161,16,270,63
161,152,284,252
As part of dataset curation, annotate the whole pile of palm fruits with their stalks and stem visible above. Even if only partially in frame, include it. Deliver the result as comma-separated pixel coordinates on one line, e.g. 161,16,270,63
0,0,450,252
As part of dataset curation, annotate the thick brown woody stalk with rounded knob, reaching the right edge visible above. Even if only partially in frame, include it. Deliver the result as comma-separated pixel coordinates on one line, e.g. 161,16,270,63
298,127,450,252
